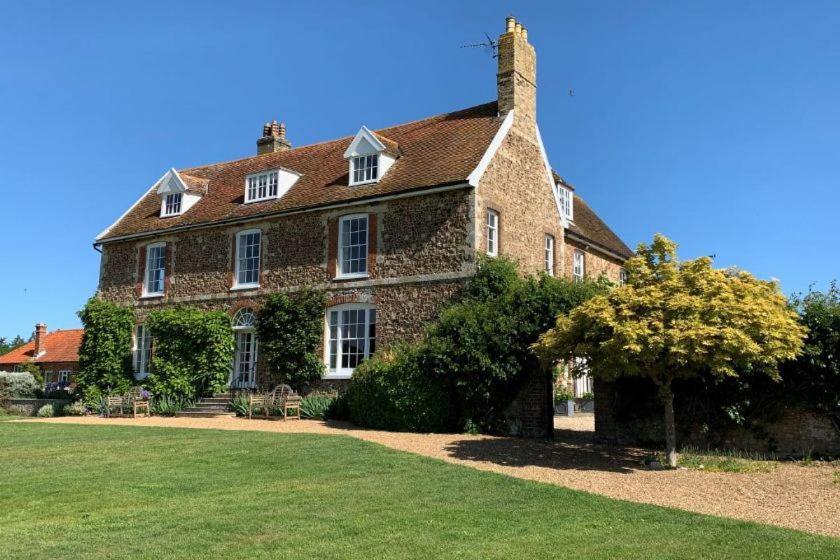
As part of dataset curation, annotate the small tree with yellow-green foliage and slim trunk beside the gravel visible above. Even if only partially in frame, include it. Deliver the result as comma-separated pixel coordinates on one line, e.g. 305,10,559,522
535,234,806,467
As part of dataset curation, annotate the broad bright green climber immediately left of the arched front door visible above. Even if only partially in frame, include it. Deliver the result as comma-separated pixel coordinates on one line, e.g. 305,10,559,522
146,307,233,401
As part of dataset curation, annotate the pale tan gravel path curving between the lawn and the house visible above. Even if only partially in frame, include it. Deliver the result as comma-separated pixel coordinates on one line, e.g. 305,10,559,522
22,416,840,537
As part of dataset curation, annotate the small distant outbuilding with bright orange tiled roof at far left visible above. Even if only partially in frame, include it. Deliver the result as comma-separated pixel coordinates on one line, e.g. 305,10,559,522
0,323,84,389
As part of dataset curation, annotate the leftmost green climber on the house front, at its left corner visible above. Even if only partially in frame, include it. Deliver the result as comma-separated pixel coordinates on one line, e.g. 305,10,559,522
76,297,134,401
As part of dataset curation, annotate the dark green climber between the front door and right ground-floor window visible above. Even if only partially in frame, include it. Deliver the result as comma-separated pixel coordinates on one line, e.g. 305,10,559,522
257,289,326,388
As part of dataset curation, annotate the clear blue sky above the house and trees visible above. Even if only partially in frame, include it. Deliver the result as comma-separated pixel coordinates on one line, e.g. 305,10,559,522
0,0,840,337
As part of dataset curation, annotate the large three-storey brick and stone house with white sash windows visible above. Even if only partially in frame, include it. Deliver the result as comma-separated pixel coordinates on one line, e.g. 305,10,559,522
95,18,630,428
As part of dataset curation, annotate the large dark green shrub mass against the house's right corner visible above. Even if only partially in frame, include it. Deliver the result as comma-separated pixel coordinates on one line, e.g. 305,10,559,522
348,258,610,432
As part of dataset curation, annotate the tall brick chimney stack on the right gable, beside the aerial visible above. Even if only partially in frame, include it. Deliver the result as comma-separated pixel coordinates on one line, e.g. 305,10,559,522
496,16,537,128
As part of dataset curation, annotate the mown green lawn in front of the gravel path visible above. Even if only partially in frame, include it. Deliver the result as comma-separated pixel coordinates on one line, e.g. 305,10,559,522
0,422,840,560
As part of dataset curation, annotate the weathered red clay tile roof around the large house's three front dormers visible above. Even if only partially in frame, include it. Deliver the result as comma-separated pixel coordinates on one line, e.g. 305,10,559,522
97,102,501,241
